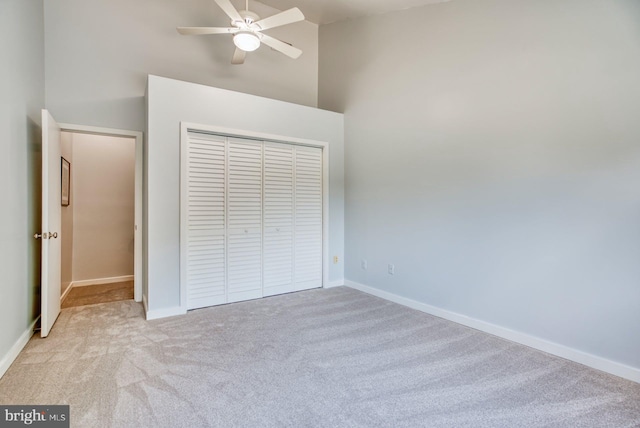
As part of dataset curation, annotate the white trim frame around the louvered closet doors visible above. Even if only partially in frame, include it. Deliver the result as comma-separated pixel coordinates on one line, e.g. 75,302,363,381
180,122,329,312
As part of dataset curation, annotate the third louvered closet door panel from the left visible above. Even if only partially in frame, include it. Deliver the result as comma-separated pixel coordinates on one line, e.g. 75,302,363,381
263,142,294,296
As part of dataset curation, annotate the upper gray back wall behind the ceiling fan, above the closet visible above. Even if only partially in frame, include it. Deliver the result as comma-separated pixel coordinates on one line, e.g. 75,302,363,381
45,0,318,131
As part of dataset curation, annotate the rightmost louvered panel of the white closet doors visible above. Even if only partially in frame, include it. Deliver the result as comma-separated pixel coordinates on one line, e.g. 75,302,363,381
294,146,322,291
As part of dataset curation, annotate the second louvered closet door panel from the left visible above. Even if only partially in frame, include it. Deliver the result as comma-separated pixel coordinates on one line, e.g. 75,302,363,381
227,138,263,302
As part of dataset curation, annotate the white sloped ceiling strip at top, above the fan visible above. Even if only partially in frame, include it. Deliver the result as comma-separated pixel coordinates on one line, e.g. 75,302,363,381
254,0,449,25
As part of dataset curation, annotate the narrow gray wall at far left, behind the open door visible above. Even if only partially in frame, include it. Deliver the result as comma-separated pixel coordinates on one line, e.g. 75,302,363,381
0,0,44,373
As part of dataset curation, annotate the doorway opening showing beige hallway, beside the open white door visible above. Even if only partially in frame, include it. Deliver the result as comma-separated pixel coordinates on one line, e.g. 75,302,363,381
60,124,142,308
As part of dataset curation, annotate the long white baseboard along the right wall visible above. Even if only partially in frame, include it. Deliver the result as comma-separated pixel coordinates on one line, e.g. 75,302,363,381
345,280,640,383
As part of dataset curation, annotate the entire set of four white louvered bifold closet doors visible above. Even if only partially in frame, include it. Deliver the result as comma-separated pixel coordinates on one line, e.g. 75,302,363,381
181,132,323,309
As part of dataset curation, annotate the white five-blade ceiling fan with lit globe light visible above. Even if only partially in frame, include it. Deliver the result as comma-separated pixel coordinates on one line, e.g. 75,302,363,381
177,0,304,64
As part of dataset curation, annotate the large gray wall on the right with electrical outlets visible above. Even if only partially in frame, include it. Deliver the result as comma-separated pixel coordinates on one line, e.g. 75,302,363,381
319,0,640,368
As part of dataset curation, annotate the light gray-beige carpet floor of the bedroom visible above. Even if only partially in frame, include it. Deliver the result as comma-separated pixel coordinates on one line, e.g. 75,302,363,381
0,287,640,428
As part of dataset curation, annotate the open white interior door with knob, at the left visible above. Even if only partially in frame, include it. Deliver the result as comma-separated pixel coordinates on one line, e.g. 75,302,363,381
37,110,62,337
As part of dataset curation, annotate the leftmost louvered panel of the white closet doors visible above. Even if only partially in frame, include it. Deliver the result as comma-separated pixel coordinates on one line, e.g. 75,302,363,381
183,134,226,309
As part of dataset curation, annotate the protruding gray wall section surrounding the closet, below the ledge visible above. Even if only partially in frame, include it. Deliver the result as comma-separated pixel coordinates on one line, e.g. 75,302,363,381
145,76,344,317
